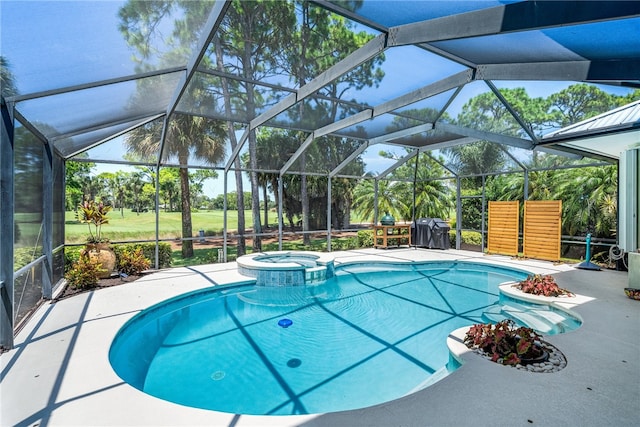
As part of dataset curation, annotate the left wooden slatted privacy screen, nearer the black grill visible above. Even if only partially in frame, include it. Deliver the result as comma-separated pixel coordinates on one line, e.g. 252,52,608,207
487,200,520,256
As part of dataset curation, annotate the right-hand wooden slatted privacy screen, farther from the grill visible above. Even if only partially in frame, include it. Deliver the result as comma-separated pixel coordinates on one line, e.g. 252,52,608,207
523,200,562,261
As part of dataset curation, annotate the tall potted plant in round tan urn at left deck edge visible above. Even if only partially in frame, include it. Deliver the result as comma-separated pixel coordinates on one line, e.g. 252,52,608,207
78,200,116,279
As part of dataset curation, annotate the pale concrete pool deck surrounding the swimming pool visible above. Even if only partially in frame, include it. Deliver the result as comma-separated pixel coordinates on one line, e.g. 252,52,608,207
0,249,640,427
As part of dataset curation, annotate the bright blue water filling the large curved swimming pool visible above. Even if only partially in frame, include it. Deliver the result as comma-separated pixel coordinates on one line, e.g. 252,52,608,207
109,262,579,415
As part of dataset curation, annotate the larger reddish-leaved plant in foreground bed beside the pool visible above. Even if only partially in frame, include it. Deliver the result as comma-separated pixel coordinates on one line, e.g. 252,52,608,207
464,319,549,365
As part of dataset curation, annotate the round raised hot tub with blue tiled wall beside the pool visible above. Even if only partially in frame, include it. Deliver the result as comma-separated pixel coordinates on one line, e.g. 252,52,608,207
237,251,335,286
